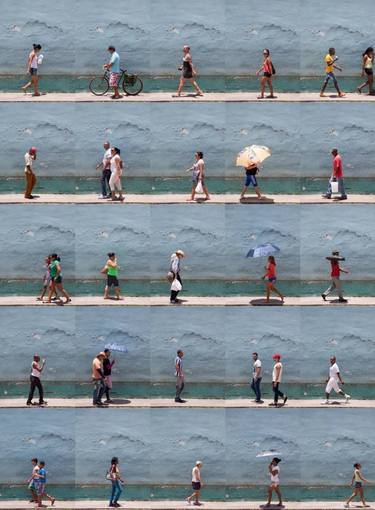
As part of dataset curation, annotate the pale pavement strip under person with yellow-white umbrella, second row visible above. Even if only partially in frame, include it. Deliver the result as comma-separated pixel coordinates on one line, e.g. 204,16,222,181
0,194,375,205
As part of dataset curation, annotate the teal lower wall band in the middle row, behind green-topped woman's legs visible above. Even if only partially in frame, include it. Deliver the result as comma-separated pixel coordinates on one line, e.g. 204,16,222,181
0,278,375,298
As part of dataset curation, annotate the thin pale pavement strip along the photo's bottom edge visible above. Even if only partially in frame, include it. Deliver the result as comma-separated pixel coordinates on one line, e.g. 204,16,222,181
0,500,375,510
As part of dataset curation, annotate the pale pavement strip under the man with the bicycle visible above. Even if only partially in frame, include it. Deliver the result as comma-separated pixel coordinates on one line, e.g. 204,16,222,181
0,92,375,104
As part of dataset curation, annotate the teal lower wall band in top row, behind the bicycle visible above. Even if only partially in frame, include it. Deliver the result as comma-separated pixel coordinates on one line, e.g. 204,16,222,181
0,73,370,93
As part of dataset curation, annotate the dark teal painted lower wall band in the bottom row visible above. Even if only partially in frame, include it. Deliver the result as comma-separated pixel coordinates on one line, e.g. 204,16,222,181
0,484,375,502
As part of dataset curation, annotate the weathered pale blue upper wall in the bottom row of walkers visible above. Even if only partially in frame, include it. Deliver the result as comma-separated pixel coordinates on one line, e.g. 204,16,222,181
0,409,375,486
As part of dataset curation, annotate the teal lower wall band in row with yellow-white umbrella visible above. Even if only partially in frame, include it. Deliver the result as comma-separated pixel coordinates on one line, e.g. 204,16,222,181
0,177,375,195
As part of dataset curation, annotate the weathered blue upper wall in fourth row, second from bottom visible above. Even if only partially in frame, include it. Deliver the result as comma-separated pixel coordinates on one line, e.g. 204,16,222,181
0,307,375,383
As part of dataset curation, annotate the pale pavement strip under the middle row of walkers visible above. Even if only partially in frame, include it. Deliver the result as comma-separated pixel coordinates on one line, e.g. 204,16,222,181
0,289,375,308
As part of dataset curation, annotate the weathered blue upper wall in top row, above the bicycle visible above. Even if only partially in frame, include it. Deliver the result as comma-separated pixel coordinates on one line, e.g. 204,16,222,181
0,0,374,75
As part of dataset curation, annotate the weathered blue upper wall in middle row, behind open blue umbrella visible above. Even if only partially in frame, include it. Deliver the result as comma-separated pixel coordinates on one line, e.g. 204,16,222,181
0,204,375,280
